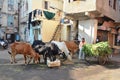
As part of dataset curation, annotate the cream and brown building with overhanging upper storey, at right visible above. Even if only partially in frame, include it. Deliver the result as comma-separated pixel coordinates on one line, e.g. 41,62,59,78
63,0,120,47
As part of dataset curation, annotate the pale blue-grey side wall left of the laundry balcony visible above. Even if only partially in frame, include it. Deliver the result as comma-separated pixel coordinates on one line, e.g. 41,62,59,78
19,0,31,42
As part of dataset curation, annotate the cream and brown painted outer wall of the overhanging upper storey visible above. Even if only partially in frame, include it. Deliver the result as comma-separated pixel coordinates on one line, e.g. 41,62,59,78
63,0,120,21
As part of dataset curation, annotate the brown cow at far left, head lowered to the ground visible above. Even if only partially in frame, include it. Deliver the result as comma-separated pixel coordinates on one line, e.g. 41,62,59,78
9,42,39,64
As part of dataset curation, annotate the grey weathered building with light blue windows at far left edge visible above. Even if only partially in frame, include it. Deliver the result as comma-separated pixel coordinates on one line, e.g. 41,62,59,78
0,0,19,42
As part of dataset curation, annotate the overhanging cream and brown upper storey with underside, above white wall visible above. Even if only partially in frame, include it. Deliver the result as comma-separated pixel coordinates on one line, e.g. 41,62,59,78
63,0,120,21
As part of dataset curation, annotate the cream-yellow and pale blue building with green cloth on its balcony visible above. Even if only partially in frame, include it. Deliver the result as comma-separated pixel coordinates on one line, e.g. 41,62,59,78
19,0,63,43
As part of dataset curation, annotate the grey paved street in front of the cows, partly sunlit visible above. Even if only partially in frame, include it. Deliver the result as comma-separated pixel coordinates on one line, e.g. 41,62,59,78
0,49,120,80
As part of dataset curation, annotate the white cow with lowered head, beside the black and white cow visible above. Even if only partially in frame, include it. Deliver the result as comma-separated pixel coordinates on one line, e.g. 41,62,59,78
51,41,72,61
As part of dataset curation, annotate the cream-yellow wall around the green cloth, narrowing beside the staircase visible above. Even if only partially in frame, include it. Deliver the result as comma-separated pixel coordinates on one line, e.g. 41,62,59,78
32,0,62,42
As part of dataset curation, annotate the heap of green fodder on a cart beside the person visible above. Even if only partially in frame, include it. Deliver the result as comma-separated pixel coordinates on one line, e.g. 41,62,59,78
82,42,112,64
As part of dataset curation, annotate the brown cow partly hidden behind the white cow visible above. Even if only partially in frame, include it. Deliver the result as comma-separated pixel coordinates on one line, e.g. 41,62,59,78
64,40,79,56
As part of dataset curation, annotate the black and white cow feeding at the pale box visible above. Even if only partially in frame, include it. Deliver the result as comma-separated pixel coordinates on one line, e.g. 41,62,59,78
32,40,66,63
